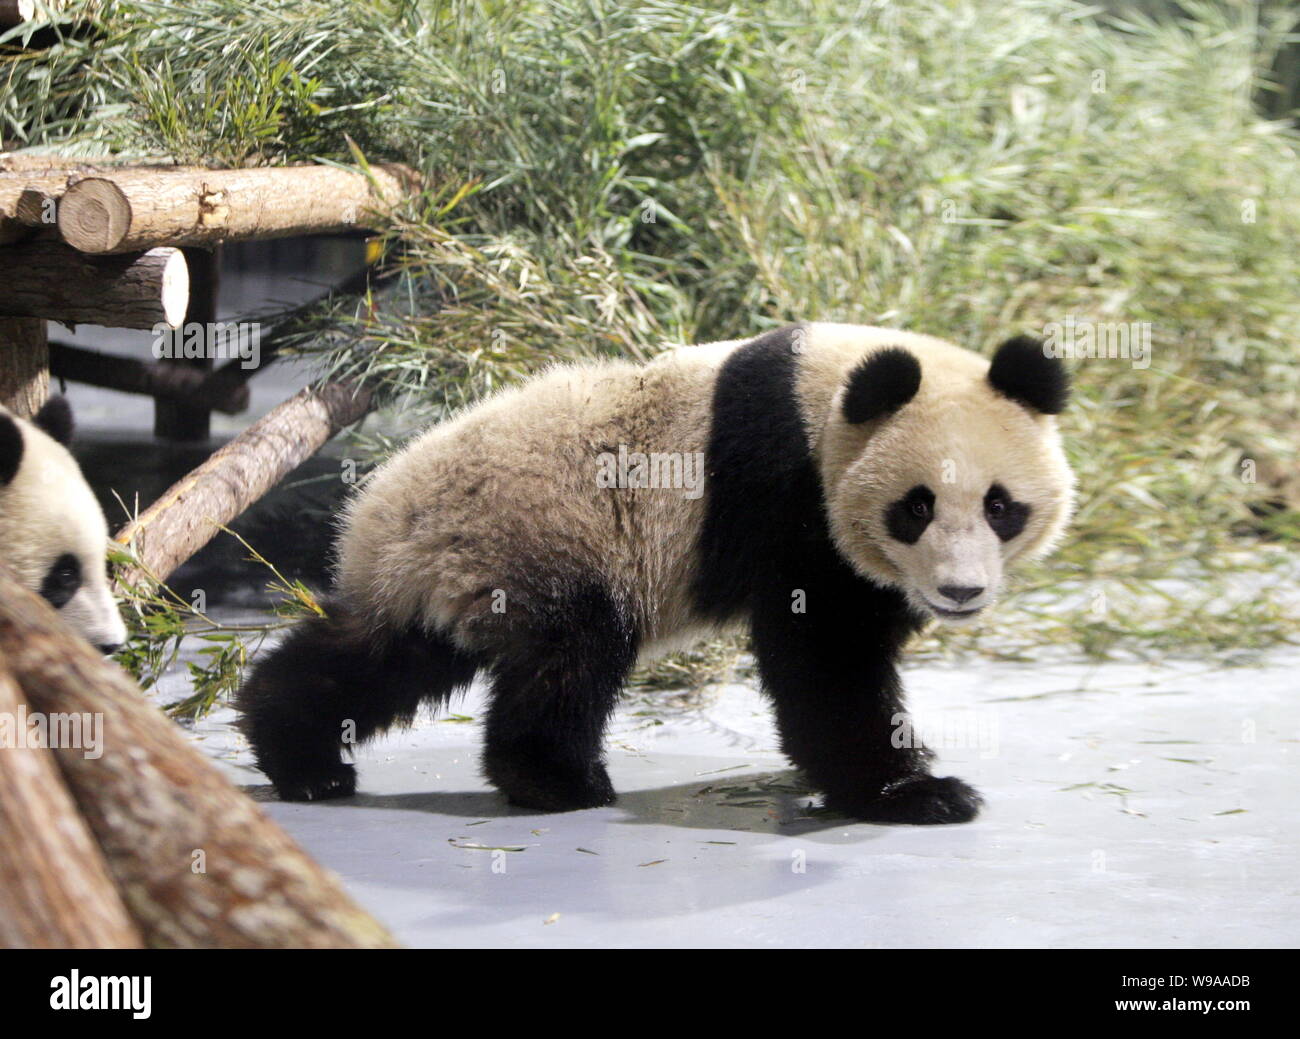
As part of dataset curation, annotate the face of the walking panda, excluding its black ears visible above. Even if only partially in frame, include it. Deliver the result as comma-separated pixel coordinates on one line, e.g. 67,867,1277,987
829,335,1073,624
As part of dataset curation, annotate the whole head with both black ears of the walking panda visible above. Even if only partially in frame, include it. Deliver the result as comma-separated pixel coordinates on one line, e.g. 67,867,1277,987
824,337,1074,623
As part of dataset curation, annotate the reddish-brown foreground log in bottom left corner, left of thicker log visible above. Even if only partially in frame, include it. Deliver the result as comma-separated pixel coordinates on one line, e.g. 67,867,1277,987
0,663,143,949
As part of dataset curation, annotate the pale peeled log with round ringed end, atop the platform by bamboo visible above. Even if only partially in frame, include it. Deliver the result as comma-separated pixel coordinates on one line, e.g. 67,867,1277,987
59,165,416,252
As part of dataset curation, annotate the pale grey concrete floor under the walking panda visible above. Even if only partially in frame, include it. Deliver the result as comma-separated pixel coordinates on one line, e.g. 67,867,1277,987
172,653,1300,948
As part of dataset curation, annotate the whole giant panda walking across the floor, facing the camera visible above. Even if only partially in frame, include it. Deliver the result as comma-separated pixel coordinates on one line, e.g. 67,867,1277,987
238,324,1073,823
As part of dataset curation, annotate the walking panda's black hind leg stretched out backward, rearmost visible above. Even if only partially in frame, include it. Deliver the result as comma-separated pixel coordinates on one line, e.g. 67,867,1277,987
235,602,478,801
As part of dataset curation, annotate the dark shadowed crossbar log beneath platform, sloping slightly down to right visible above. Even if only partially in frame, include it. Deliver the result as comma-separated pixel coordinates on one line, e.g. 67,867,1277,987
49,342,248,415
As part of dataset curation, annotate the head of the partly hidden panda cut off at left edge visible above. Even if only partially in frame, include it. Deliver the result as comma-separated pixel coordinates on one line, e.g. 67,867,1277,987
0,398,126,653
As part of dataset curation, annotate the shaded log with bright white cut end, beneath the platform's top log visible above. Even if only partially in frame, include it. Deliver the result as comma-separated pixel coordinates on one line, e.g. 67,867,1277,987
0,238,190,329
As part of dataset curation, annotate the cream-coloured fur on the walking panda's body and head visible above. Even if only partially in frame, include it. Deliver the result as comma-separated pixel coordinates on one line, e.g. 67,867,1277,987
338,324,1071,653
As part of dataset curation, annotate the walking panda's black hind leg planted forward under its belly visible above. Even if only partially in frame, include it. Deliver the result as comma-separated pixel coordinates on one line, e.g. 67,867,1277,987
484,586,637,811
